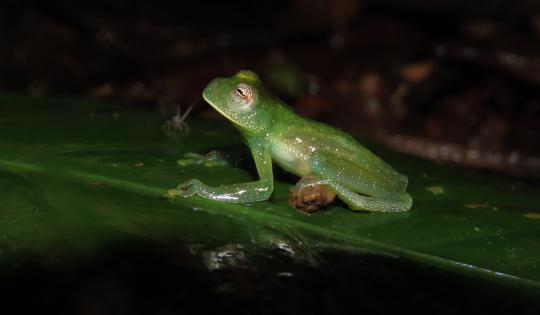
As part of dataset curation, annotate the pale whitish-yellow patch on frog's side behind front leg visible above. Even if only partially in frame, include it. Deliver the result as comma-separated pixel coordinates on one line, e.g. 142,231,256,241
271,144,311,176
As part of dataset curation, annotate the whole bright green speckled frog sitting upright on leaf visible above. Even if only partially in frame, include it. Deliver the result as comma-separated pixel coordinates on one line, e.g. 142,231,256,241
172,70,412,212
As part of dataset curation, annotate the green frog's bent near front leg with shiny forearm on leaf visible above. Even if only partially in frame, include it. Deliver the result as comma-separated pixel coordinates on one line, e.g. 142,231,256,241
169,139,274,203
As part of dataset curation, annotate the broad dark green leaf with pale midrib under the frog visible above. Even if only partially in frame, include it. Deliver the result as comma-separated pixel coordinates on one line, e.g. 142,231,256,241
0,95,540,296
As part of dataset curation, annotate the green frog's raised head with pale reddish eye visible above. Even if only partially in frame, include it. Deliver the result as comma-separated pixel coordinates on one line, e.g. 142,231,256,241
203,70,271,133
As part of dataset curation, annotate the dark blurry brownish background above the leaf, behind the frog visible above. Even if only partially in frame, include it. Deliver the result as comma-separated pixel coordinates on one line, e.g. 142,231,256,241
4,0,540,179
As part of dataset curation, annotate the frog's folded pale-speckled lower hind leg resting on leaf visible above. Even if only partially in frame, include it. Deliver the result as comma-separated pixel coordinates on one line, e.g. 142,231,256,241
319,178,412,212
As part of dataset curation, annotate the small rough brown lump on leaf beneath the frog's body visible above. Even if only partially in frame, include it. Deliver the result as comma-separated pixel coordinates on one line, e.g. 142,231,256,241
289,174,336,214
